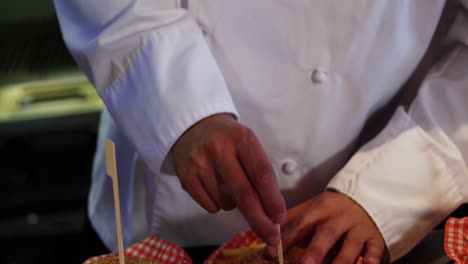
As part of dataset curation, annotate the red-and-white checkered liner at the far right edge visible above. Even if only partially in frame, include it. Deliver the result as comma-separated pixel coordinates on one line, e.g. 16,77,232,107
444,217,468,264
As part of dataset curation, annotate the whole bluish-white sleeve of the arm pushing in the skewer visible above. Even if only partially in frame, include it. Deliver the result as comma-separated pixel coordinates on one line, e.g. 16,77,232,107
54,0,237,173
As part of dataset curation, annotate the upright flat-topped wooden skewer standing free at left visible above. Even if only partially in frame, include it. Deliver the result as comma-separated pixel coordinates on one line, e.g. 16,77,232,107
105,139,125,264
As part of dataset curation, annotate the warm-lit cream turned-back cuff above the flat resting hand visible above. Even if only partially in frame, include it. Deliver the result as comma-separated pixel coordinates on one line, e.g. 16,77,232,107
327,108,466,261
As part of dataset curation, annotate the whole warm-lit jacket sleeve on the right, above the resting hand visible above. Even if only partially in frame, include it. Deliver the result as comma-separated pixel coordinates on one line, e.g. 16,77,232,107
327,0,468,260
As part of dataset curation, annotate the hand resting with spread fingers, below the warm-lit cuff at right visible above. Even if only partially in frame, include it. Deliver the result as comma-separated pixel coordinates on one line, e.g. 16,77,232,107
272,191,385,264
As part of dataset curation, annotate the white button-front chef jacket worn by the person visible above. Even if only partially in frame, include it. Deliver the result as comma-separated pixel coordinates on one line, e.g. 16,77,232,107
55,0,468,259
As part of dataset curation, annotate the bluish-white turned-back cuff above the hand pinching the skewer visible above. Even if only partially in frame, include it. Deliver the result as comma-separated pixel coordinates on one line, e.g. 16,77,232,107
98,15,237,173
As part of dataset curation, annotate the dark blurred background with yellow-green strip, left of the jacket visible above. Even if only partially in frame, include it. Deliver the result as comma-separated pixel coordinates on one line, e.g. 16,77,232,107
0,0,105,264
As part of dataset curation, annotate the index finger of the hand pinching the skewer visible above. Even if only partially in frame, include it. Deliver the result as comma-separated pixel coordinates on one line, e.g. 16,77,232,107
238,130,286,223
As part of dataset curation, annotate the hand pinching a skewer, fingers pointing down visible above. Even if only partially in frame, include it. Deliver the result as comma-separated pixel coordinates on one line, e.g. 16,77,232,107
171,114,286,245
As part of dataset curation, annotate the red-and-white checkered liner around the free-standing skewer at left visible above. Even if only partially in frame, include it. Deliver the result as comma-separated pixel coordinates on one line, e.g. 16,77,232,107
83,236,192,264
